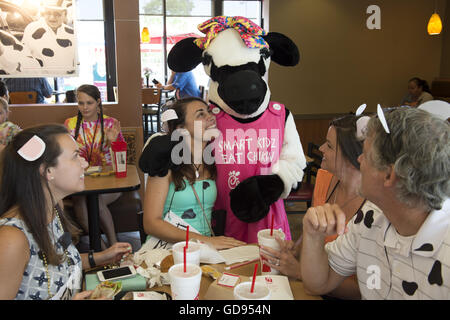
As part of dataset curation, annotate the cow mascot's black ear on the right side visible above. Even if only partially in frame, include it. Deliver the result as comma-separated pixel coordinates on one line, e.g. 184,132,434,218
263,32,300,67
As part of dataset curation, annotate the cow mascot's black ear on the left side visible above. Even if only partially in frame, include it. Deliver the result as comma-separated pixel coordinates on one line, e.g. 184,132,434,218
167,37,203,72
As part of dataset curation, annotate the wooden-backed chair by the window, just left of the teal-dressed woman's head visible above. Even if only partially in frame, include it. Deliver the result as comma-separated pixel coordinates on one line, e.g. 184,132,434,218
142,88,162,141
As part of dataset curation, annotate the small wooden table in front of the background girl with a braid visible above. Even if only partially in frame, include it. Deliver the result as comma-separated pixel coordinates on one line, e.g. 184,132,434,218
73,165,141,251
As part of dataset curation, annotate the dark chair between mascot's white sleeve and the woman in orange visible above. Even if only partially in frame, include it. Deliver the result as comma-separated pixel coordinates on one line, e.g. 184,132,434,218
284,142,322,213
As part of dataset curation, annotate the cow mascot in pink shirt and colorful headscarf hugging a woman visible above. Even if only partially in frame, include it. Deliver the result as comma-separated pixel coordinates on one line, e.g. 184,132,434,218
139,16,306,243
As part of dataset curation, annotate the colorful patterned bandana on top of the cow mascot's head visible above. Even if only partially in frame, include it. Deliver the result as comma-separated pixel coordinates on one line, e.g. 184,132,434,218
194,16,269,50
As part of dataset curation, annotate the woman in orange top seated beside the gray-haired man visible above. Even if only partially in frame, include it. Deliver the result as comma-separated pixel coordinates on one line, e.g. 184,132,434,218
263,112,369,299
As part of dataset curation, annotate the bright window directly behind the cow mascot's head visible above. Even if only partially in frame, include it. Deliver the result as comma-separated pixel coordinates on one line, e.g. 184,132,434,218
139,0,261,87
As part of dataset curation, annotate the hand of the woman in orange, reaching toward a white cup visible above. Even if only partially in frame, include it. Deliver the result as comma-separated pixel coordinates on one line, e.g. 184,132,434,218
260,238,301,280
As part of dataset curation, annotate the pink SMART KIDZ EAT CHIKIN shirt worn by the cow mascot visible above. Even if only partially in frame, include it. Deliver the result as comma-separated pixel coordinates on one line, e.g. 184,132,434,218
211,101,291,243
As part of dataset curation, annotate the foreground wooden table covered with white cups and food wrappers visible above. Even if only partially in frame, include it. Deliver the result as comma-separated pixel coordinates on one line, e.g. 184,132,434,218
148,263,323,300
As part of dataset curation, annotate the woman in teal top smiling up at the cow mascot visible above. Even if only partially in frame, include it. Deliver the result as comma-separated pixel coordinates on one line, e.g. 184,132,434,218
144,98,245,249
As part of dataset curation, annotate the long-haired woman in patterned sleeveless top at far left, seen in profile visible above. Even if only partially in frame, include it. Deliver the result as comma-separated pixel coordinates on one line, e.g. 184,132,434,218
0,125,131,300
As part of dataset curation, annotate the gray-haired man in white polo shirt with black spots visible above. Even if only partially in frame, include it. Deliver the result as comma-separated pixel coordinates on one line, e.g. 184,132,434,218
301,108,450,299
